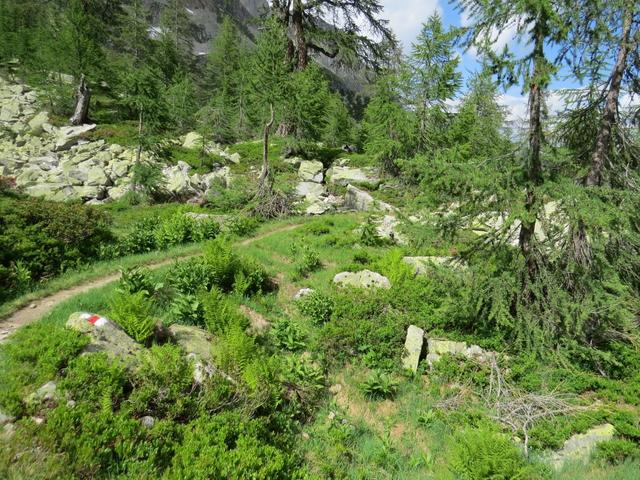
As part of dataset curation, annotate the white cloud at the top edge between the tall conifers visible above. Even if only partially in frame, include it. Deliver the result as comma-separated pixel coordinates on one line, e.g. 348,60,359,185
382,0,442,51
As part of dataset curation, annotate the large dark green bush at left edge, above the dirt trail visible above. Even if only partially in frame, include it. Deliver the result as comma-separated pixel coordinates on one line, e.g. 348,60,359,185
0,194,114,301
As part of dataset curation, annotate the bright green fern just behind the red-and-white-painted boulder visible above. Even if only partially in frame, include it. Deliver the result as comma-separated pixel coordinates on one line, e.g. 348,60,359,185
108,292,156,343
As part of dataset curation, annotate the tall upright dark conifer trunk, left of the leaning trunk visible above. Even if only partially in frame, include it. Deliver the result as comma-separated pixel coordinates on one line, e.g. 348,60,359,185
519,22,545,279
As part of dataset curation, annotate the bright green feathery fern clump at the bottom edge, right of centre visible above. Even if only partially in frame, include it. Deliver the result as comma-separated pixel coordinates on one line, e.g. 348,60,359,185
450,428,550,480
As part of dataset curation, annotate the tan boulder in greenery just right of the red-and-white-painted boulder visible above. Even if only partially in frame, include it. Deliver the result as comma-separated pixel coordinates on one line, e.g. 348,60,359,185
169,324,214,385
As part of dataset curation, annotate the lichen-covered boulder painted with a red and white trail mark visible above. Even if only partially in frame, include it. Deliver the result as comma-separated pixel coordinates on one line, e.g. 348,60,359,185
66,312,143,368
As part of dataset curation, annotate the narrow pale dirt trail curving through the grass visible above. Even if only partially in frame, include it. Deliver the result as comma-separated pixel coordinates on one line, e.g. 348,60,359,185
0,224,300,343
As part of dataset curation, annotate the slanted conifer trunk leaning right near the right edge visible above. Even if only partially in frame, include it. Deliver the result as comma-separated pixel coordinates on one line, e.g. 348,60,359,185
584,9,632,187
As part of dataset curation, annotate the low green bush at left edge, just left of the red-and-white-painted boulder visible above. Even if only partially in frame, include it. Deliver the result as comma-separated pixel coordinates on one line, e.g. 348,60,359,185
0,323,88,416
